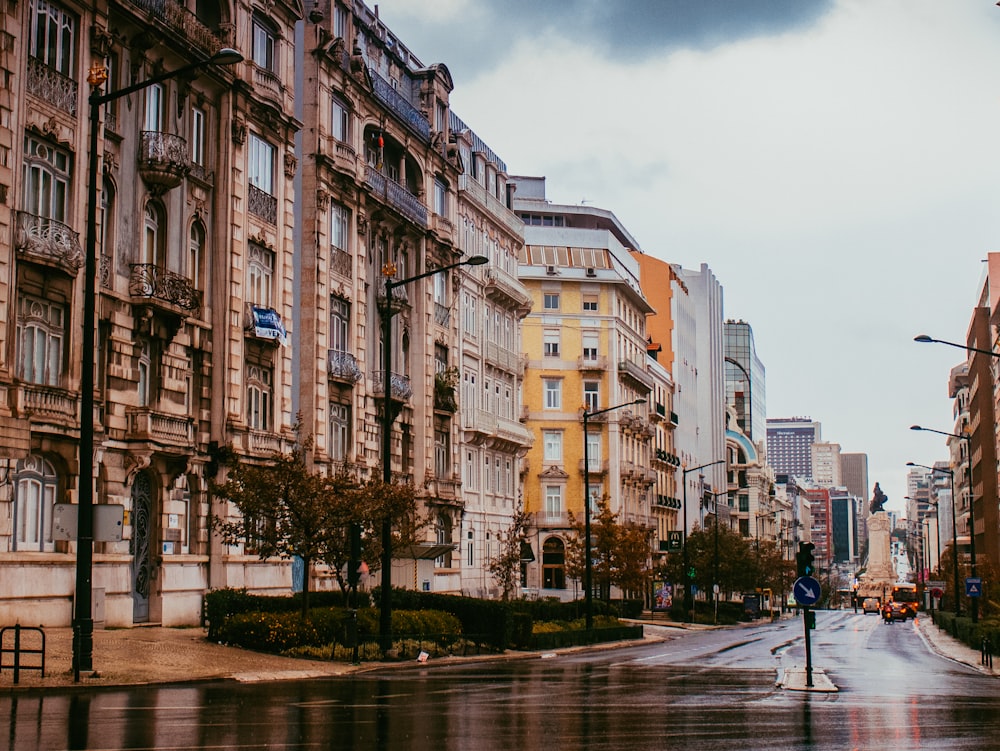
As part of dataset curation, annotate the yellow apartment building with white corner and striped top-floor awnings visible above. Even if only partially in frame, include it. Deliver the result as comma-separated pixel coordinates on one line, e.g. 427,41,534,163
514,177,665,599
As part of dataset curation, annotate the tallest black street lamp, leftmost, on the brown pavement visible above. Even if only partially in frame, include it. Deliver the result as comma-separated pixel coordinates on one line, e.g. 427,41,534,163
73,47,243,679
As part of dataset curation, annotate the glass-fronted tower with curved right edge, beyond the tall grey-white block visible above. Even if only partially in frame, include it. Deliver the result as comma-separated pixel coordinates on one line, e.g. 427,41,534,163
723,320,767,444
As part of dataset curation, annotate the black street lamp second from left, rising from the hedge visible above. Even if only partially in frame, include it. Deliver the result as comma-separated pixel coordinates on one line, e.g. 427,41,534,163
379,256,490,652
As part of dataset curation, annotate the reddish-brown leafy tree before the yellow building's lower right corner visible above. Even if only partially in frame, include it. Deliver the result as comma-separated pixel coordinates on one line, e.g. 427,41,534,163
566,496,652,599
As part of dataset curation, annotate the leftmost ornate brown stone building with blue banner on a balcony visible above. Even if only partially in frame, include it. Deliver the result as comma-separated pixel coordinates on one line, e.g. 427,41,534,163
0,0,300,626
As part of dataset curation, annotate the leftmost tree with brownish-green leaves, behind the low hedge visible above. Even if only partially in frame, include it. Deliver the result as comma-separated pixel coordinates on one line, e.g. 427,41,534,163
212,440,344,615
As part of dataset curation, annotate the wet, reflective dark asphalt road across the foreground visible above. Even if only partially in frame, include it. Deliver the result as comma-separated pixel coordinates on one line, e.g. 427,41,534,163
0,612,1000,751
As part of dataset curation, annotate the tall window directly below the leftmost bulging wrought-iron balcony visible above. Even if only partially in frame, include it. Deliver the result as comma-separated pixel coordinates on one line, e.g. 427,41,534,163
17,294,65,386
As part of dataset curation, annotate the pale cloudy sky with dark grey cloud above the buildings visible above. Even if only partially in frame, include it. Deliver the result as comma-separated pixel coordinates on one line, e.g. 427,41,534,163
379,0,1000,509
